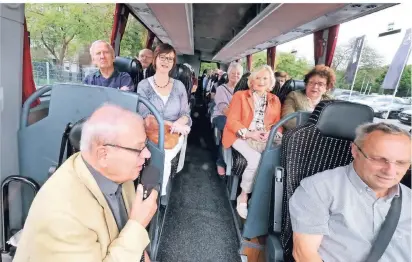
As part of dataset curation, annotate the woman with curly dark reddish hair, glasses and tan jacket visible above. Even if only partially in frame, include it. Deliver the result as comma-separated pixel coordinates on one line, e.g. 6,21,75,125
282,65,336,129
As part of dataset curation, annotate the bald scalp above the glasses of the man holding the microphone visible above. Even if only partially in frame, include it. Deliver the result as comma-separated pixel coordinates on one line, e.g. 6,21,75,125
80,104,146,152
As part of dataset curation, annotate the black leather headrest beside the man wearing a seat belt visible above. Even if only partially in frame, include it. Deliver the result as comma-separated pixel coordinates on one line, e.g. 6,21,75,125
309,100,374,141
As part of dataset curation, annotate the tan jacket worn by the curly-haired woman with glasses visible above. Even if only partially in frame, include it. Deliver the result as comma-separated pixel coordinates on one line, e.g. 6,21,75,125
282,90,333,130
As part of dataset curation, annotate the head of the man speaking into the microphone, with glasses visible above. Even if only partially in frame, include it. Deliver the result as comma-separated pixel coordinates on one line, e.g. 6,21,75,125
80,104,150,184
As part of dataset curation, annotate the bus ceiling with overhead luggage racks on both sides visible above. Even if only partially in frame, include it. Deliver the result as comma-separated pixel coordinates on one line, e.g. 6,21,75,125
120,3,396,63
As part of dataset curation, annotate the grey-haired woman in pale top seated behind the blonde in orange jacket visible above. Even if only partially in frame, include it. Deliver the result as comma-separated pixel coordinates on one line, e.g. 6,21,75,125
212,63,243,176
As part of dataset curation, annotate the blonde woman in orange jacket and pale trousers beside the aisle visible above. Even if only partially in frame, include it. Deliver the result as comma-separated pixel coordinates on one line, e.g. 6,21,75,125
222,65,281,218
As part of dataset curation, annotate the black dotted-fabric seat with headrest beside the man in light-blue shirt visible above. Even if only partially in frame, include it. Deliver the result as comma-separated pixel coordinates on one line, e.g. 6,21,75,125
280,100,373,261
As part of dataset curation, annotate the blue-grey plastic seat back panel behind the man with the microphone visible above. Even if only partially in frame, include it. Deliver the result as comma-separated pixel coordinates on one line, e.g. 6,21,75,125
18,84,164,188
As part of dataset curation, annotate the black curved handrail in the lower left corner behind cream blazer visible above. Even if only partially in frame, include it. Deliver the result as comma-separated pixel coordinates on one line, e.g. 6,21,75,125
1,176,40,253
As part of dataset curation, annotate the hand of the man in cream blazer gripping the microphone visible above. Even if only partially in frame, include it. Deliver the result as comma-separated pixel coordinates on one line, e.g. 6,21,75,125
130,184,159,227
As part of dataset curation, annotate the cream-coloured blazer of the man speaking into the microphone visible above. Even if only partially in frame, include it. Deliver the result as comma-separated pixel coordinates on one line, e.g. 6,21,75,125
13,153,150,262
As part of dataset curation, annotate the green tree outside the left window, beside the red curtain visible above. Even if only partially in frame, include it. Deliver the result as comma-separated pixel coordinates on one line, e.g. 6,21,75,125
26,4,115,65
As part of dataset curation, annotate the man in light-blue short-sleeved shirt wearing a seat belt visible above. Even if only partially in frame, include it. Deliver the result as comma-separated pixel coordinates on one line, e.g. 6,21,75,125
289,122,412,262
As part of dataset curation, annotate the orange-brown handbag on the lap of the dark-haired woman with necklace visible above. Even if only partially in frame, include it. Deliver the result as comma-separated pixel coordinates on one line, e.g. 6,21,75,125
145,117,180,149
